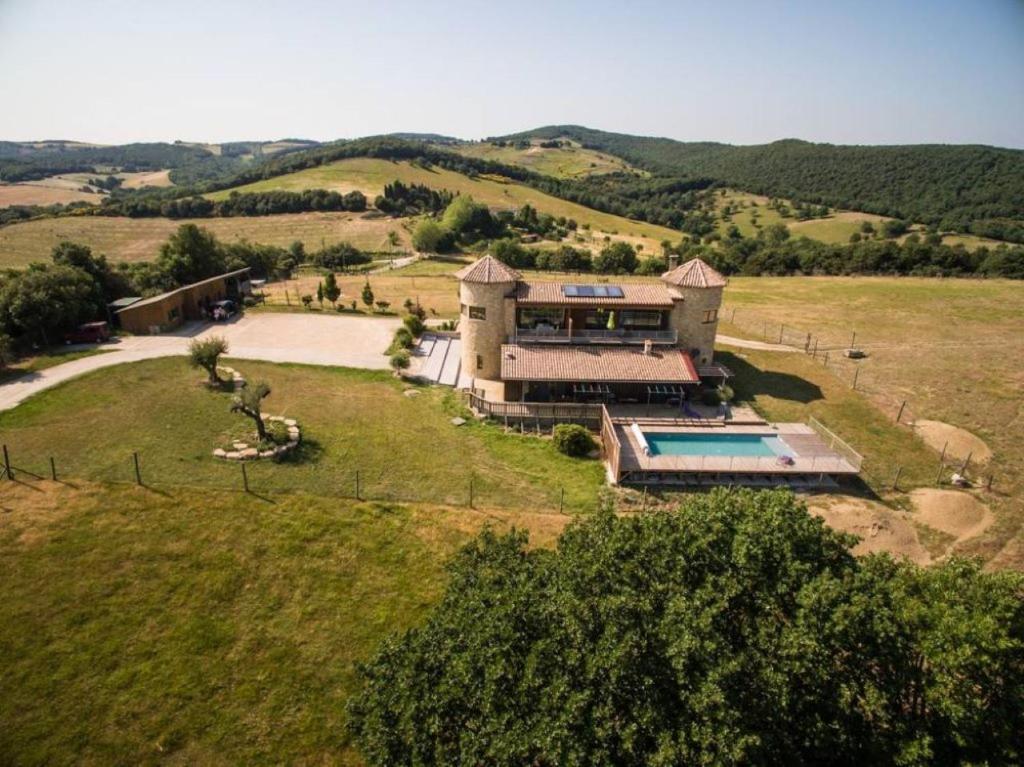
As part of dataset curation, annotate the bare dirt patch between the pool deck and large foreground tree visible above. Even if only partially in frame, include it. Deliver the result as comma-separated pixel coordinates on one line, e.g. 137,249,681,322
809,498,932,564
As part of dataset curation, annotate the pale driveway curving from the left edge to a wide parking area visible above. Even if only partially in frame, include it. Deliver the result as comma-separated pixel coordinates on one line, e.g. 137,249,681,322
0,313,400,411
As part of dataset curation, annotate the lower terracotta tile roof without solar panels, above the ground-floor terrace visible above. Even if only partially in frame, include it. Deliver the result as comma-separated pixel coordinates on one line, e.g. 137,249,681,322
502,344,700,383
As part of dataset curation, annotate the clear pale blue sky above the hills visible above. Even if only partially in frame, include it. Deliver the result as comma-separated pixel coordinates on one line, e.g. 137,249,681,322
0,0,1024,147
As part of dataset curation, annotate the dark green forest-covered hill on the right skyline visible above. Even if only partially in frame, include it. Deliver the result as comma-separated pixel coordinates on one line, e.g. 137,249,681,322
502,125,1024,242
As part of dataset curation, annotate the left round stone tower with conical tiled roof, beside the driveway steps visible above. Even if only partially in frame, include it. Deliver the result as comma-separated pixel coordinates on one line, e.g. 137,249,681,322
456,256,521,380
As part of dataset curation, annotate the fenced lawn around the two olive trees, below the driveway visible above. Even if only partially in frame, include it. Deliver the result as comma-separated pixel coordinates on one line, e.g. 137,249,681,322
0,357,604,511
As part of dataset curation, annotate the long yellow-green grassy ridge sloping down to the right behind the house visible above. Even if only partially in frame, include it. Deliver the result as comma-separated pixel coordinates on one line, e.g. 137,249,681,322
204,158,679,249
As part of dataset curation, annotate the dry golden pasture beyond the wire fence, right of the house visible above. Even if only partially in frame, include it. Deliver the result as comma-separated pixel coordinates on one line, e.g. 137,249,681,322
720,278,1024,566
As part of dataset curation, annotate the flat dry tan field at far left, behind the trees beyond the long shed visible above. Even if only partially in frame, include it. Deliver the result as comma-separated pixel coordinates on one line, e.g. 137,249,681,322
0,213,412,268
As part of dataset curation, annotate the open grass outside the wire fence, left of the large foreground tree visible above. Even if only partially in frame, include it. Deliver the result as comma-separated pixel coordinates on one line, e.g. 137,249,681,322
0,482,565,765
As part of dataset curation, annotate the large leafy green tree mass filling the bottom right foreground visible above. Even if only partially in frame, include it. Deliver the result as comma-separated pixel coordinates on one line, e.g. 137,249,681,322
349,491,1024,765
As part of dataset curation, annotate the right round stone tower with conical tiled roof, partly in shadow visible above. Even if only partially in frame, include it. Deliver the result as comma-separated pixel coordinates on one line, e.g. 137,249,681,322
662,258,727,365
